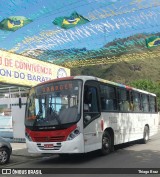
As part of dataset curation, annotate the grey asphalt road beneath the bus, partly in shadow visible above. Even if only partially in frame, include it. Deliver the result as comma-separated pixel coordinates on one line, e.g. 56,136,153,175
1,131,160,177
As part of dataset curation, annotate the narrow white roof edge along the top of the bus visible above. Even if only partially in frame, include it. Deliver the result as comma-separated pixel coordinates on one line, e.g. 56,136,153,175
38,75,156,96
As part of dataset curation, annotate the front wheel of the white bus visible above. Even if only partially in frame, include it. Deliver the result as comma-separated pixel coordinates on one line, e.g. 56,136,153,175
101,131,112,155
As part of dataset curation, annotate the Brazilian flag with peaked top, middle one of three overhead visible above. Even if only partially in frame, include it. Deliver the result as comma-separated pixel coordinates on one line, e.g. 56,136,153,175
53,12,89,29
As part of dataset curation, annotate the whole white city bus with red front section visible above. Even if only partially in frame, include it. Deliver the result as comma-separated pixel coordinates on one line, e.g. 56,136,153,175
25,76,158,155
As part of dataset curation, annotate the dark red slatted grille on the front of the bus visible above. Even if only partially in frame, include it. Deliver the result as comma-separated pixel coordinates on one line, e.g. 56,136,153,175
34,136,65,142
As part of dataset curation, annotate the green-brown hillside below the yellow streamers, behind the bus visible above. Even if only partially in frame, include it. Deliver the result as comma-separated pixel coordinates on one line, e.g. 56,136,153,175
71,53,160,84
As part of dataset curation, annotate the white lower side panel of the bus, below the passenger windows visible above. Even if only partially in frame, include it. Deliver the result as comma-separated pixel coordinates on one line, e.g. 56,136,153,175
97,112,158,145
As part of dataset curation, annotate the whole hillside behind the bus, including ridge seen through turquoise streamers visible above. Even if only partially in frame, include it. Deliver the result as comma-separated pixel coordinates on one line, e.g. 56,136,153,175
71,33,160,84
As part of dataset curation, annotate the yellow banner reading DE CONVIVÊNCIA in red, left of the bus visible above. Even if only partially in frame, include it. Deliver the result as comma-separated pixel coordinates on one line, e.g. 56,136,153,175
0,50,70,86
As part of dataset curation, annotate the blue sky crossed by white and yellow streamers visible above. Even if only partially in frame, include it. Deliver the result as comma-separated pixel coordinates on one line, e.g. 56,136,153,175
0,0,160,62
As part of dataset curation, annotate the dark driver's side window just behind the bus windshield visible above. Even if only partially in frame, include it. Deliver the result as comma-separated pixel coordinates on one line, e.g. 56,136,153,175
83,85,100,125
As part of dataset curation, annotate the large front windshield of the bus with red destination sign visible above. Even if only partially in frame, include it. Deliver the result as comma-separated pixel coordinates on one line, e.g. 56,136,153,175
25,80,82,129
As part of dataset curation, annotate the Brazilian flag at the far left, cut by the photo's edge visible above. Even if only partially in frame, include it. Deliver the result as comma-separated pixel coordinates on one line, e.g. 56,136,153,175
0,16,32,31
